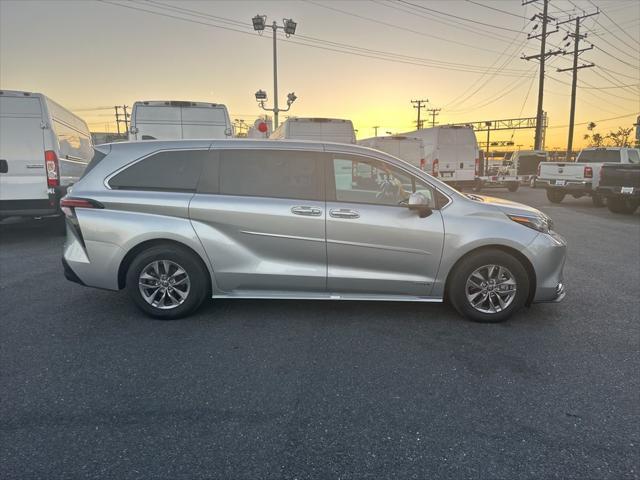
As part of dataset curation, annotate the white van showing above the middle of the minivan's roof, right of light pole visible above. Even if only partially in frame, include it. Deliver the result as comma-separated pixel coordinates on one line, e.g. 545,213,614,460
269,117,356,143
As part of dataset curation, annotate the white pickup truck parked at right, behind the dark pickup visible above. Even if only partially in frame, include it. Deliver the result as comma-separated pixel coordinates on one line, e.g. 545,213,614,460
536,147,640,206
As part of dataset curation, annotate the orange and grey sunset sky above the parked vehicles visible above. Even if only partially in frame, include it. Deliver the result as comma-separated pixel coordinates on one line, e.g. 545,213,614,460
0,0,640,149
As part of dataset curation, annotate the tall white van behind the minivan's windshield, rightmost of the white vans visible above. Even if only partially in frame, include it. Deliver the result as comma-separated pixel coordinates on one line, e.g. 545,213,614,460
403,125,480,187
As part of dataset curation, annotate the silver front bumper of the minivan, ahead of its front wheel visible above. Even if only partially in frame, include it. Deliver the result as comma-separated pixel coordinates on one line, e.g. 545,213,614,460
523,232,567,303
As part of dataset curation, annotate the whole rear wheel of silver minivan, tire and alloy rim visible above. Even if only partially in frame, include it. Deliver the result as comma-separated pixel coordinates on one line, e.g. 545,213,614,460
125,245,209,320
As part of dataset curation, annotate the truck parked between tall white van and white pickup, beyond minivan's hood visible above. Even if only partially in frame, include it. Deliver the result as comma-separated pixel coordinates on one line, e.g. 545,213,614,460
474,150,548,192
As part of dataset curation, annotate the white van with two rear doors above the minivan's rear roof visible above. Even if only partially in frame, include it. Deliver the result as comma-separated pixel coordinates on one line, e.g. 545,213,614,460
129,100,233,140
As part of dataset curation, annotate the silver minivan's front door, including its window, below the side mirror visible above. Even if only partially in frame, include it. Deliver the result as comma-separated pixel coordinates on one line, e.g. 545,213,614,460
327,155,444,297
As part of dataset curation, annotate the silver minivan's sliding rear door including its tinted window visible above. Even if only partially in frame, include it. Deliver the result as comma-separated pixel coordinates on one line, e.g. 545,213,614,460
189,150,327,296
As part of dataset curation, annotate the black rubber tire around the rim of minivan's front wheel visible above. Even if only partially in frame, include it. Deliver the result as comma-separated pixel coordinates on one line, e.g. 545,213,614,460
447,249,530,323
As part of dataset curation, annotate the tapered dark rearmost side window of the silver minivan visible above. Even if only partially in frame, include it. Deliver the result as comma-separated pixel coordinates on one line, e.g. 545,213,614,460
109,150,209,192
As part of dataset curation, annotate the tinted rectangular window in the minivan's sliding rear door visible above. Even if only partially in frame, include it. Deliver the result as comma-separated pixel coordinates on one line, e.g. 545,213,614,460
219,150,324,200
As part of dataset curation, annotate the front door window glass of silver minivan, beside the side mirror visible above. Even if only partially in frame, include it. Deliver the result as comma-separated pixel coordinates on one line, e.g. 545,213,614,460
333,157,435,206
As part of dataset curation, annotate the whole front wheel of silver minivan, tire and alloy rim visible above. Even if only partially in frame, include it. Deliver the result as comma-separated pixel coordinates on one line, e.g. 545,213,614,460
448,249,530,323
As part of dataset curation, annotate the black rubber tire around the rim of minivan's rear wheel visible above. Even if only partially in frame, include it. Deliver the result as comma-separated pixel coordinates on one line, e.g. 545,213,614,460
125,244,210,320
